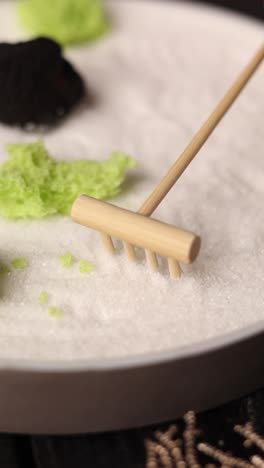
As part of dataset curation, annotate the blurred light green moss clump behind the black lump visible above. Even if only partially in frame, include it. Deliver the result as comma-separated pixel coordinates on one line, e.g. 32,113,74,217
18,0,110,45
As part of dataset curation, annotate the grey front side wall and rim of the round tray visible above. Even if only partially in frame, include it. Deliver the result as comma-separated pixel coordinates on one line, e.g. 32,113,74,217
0,322,264,434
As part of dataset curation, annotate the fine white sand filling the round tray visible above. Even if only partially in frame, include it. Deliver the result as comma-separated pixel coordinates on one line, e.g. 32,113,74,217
0,0,264,360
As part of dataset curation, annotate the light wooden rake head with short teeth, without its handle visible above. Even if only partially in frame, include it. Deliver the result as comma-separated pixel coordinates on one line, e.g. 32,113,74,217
71,195,201,278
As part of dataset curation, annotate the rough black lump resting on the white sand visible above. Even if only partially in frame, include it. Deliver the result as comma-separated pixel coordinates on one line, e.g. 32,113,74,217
0,38,85,127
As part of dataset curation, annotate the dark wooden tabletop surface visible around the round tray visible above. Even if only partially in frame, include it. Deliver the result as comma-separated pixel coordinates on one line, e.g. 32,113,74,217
0,0,264,468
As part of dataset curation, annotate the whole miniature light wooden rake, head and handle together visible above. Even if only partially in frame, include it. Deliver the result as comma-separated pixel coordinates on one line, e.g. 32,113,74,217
71,44,264,278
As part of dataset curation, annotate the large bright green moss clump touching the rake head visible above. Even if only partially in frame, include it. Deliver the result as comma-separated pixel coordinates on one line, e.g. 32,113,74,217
0,141,135,219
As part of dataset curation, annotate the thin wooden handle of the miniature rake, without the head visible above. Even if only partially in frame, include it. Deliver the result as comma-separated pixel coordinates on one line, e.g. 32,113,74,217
139,44,264,216
